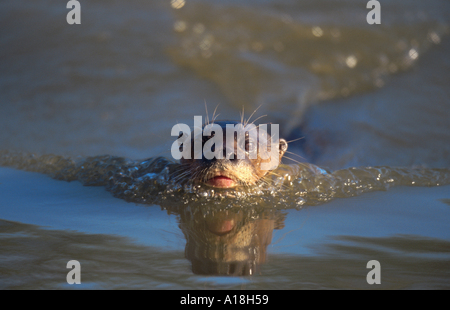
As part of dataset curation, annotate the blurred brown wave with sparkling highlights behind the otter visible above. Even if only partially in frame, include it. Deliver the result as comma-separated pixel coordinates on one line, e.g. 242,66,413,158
169,1,449,115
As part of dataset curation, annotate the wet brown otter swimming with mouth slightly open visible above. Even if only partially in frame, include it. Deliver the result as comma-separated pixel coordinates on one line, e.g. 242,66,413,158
179,120,288,189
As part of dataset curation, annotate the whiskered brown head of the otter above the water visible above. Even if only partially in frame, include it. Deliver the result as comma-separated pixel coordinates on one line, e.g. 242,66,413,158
179,121,287,188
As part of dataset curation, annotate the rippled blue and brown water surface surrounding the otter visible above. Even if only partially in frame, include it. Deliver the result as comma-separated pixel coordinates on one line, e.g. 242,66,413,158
0,0,450,289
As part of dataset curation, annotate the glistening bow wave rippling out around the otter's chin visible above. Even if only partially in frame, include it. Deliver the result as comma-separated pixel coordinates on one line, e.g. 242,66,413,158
0,151,450,209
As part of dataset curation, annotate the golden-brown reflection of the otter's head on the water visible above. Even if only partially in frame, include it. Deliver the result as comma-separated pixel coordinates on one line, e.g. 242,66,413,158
167,205,285,276
